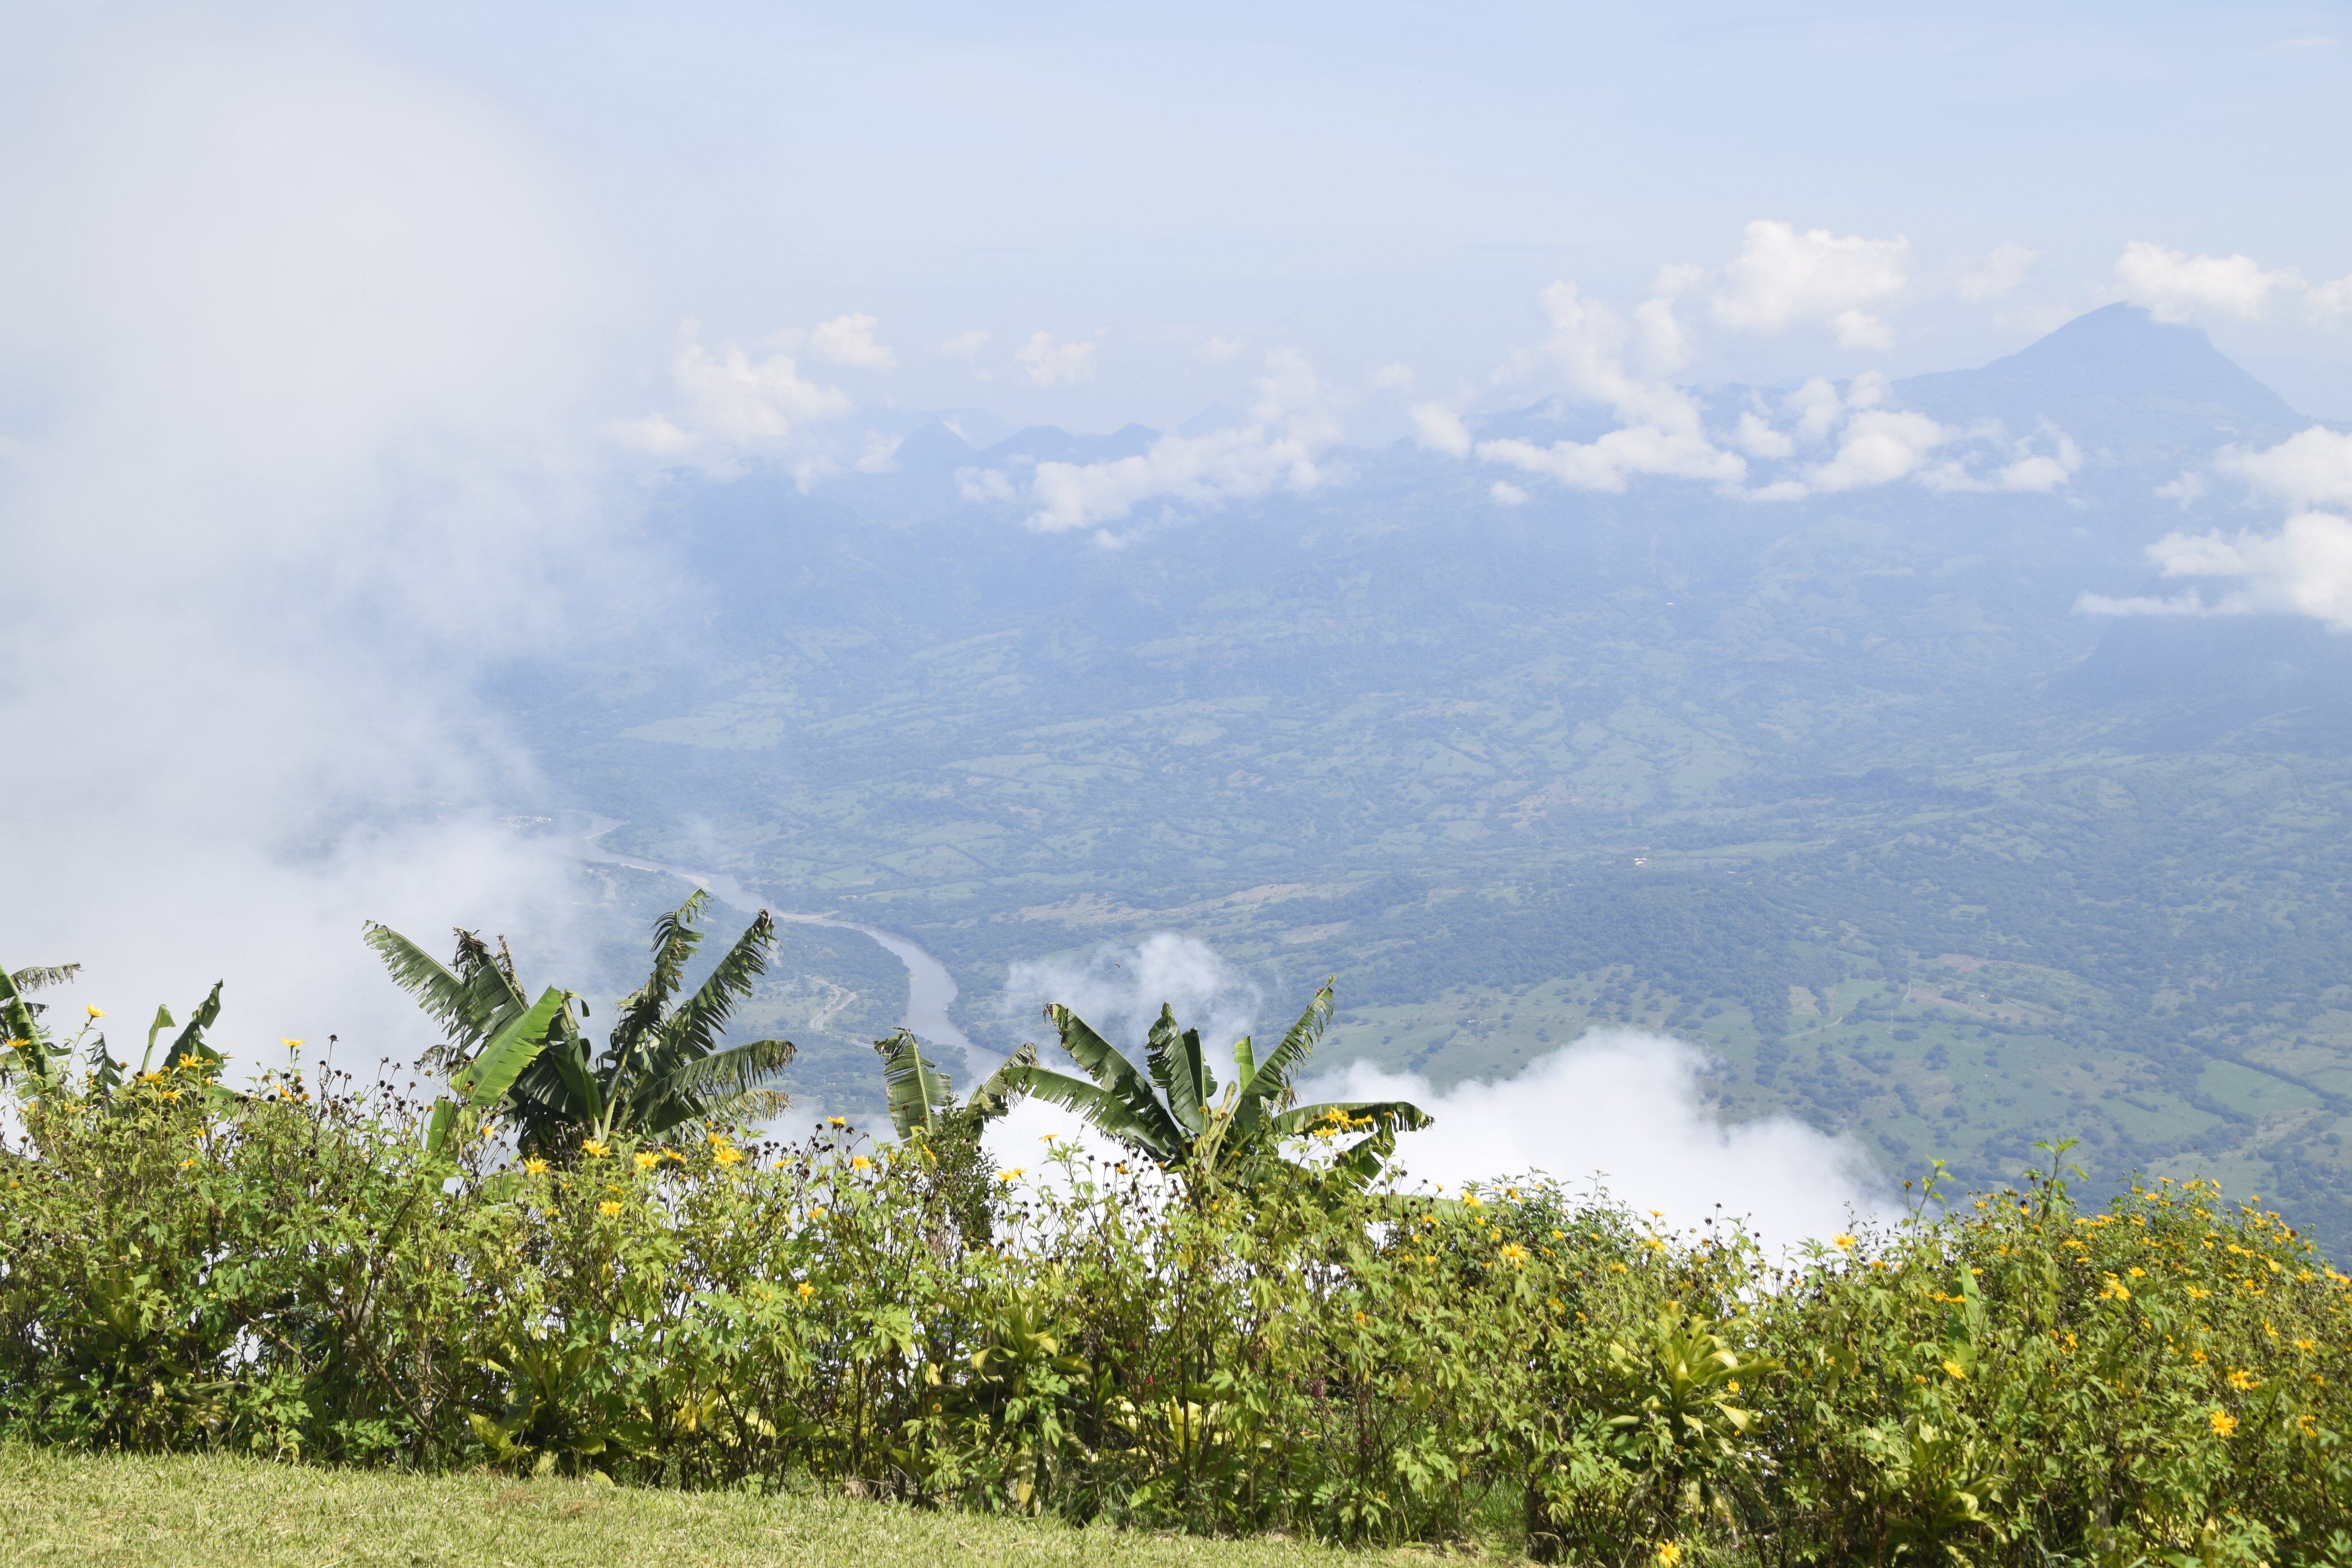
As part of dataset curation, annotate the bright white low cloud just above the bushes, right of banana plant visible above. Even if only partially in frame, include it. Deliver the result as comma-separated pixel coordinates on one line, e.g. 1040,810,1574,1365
1301,1029,1891,1248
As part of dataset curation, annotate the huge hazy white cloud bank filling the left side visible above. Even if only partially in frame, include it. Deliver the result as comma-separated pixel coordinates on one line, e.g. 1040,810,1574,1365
0,33,625,1081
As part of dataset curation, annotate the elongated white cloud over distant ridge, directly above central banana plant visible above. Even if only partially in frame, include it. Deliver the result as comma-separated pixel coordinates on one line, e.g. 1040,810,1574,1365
964,348,1343,533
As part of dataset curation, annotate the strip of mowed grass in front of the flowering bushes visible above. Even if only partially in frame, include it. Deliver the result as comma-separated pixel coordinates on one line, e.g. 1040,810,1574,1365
0,1446,1432,1568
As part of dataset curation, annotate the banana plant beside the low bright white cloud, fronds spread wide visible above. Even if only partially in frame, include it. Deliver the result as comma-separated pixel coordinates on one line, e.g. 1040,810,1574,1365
1004,980,1430,1192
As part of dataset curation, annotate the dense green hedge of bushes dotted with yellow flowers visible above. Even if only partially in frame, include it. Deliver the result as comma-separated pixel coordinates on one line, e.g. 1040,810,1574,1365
0,1060,2352,1566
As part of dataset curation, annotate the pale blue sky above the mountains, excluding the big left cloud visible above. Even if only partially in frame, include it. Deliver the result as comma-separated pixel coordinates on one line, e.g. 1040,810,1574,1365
322,5,2352,425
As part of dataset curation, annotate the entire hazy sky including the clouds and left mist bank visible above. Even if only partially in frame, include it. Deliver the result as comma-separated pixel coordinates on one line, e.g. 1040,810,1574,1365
0,0,2352,1222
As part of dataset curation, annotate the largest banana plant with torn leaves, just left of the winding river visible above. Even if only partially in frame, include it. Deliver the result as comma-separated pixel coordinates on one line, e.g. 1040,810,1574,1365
367,891,792,1152
